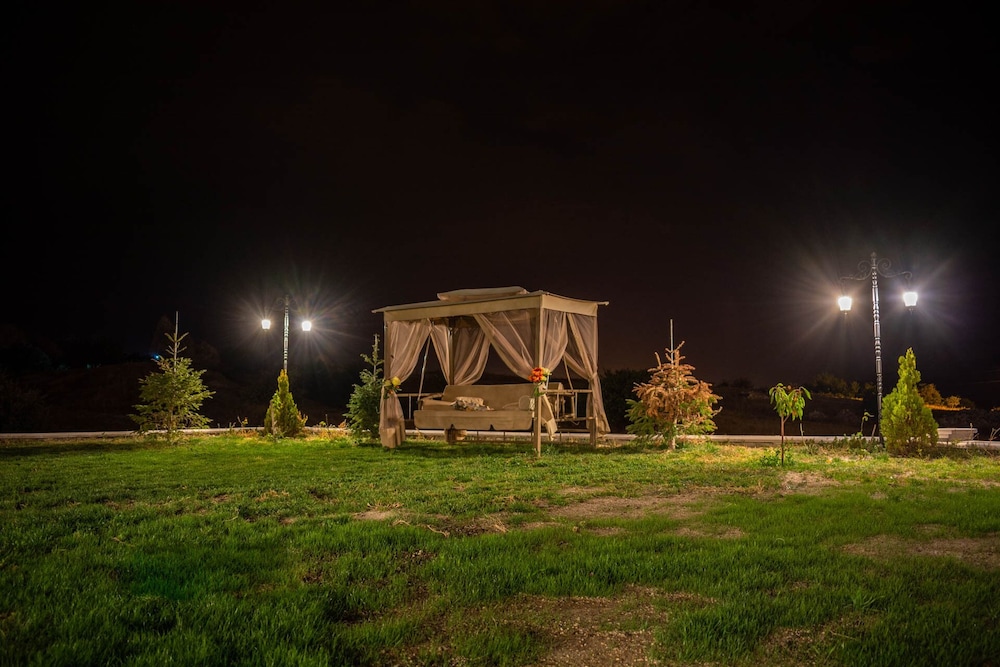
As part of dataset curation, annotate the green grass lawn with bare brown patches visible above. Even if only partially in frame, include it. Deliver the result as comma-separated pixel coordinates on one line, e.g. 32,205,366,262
0,433,1000,667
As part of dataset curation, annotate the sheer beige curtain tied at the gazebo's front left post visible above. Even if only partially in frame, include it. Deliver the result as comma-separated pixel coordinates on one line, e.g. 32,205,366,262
378,320,431,447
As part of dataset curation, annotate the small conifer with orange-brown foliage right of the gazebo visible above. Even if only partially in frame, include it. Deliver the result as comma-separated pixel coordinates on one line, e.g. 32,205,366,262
626,342,722,449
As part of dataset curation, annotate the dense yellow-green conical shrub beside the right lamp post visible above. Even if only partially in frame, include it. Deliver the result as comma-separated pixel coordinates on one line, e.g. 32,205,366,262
879,348,938,456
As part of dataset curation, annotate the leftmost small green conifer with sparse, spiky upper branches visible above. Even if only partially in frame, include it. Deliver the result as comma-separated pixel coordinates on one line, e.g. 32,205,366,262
130,320,215,442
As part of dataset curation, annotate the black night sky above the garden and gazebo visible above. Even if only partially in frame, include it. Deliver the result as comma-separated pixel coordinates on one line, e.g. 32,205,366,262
0,0,1000,403
